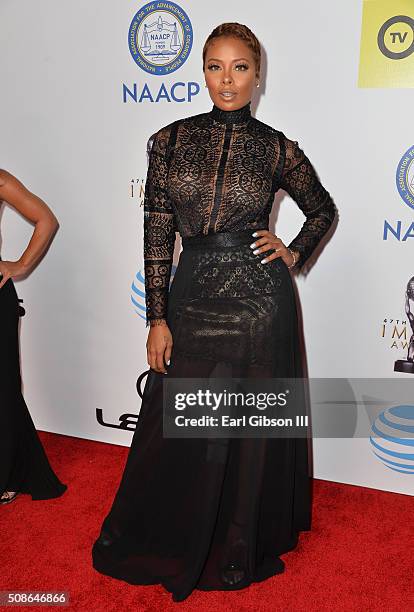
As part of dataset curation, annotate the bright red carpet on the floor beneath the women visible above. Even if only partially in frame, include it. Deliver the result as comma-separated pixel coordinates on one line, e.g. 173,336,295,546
0,433,414,612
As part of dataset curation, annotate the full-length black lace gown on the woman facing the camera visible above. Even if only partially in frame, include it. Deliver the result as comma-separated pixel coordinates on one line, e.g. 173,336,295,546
93,104,336,601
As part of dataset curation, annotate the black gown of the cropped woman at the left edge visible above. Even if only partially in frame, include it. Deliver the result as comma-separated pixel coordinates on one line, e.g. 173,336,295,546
0,272,66,500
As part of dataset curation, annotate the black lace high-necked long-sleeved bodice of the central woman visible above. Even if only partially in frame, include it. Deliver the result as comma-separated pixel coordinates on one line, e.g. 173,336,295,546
144,103,336,326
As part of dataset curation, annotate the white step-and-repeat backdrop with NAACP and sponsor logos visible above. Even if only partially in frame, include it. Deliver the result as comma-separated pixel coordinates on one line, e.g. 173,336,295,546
0,0,414,495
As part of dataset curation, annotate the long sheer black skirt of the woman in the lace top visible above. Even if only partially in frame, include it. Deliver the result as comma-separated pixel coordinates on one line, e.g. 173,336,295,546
93,230,311,601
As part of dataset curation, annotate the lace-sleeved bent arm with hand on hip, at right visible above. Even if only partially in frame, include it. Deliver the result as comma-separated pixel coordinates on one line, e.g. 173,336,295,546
280,134,337,268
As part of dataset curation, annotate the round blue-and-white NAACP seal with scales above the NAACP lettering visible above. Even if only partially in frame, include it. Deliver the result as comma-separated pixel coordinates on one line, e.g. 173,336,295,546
128,2,193,75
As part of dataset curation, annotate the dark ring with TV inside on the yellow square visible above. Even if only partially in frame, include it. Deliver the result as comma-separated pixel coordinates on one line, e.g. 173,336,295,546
378,15,414,60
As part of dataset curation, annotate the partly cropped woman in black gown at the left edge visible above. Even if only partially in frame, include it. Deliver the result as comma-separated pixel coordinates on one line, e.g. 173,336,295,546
0,170,66,504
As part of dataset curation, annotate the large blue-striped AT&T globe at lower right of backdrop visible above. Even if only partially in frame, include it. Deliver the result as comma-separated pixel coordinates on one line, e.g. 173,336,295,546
370,405,414,474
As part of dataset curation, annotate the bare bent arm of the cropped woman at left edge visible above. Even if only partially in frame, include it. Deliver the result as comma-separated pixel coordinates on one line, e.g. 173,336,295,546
0,170,58,288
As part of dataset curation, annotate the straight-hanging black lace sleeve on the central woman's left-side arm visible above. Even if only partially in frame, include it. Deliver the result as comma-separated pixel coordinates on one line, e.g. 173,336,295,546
144,128,176,327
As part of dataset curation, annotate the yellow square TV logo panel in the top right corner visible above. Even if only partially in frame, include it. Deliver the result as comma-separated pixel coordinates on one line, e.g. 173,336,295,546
358,0,414,88
